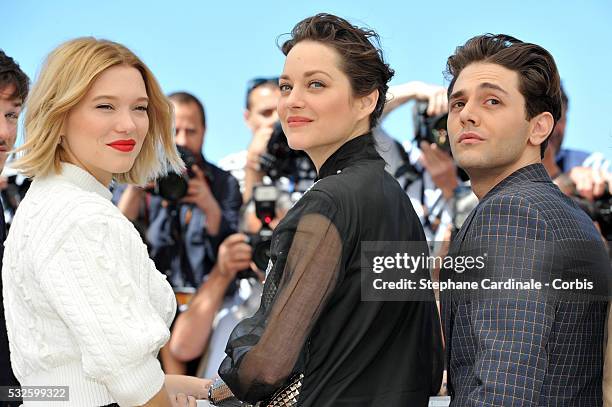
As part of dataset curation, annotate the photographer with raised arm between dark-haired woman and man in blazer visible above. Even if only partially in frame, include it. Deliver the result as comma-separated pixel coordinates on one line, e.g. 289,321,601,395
374,81,471,247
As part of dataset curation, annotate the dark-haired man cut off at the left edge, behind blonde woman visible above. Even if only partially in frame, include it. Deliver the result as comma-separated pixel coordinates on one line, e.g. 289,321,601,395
0,50,29,406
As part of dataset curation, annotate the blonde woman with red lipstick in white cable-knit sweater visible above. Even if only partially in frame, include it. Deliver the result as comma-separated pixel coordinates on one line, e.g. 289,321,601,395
2,38,209,407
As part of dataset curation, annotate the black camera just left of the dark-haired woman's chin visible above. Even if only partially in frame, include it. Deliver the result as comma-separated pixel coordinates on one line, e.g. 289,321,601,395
259,122,317,185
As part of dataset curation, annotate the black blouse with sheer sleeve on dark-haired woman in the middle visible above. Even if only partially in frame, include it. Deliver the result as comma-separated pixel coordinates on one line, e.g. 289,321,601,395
219,134,442,407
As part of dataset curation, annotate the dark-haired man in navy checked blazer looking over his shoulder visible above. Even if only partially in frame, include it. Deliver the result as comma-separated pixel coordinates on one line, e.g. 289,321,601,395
442,34,609,407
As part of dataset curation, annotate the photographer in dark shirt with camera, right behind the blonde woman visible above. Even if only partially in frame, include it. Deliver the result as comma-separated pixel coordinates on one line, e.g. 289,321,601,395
115,92,242,374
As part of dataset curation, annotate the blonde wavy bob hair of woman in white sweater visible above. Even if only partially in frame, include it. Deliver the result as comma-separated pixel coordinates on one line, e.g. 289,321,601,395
11,37,183,185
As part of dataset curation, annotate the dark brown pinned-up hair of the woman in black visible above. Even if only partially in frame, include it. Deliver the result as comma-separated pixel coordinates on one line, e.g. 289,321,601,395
281,13,395,129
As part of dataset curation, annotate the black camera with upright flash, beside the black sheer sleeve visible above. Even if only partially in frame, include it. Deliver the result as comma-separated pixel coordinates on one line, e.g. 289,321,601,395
237,185,279,278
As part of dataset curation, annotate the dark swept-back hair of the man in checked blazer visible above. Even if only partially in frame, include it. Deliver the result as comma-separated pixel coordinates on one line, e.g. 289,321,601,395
446,34,563,157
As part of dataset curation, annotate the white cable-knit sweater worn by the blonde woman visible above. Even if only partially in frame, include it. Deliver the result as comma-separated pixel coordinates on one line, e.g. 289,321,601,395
2,164,176,407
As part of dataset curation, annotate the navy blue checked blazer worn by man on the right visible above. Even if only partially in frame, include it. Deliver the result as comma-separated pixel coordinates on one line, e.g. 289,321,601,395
441,164,607,407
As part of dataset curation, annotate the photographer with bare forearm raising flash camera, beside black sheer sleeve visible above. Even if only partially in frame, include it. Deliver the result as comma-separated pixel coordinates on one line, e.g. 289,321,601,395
169,186,291,402
